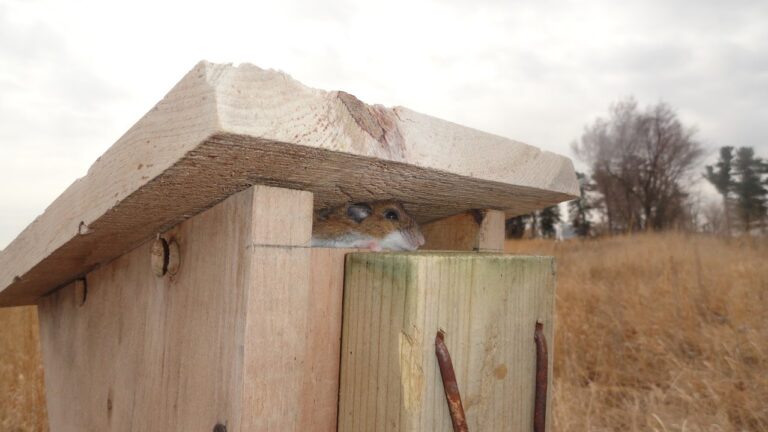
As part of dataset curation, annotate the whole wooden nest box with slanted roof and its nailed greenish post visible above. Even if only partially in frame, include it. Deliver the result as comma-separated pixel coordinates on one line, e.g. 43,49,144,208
0,62,578,432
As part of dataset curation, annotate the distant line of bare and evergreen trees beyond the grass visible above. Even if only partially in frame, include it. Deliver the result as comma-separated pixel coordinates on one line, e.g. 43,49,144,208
506,98,768,238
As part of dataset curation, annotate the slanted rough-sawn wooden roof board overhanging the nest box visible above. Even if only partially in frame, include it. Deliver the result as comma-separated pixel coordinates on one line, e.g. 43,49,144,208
0,62,578,306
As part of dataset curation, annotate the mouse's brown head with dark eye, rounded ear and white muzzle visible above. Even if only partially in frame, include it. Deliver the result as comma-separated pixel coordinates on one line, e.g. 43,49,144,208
316,201,424,250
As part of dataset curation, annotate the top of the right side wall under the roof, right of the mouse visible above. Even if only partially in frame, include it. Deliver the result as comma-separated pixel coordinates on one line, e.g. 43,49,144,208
421,210,505,252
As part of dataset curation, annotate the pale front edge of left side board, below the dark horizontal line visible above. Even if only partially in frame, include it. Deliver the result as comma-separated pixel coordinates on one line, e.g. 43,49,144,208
243,247,311,431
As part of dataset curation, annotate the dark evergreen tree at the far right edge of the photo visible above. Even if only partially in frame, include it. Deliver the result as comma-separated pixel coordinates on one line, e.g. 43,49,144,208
734,147,768,232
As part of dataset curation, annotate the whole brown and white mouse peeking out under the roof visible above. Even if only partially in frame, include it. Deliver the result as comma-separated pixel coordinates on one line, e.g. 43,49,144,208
312,201,424,252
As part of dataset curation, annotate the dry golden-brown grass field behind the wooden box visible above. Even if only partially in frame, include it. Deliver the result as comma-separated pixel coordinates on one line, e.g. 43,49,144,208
0,233,768,432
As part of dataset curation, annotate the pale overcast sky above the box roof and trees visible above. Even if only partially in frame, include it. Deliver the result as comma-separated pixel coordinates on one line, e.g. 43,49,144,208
0,0,768,248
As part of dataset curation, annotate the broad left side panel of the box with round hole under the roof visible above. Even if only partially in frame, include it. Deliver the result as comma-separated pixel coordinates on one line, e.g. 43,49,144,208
39,190,252,431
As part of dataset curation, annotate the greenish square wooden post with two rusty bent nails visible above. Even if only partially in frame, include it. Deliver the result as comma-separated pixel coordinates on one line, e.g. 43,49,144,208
339,252,554,432
